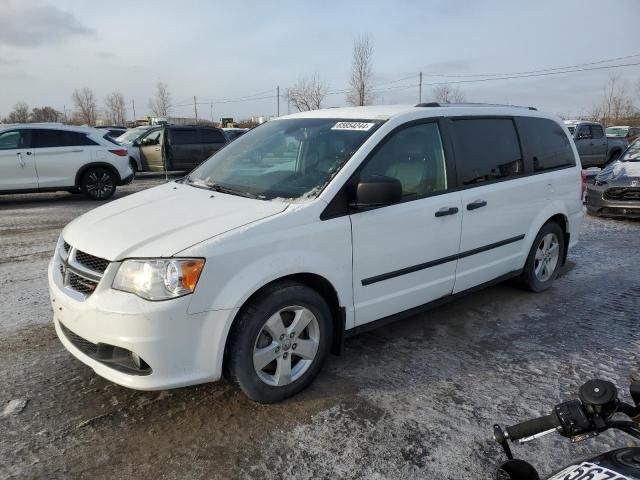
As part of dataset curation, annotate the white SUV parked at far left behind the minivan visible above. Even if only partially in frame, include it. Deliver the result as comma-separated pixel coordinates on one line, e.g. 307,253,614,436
0,124,133,200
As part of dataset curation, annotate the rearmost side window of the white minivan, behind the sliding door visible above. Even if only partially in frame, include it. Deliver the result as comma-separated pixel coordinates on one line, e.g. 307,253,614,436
516,117,576,172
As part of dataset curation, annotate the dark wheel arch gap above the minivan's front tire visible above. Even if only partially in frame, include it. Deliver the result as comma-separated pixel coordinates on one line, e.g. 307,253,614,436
222,272,345,374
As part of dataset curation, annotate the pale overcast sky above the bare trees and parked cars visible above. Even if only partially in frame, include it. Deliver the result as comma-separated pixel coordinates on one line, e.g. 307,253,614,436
0,0,640,119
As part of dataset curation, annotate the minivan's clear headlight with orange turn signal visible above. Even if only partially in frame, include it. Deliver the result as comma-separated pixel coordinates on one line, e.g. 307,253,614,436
111,258,204,300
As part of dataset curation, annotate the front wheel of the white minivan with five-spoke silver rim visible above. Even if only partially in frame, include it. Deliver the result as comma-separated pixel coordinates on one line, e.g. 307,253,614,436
226,281,333,403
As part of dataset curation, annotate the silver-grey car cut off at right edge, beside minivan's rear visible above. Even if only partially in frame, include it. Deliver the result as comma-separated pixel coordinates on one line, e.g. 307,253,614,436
586,140,640,218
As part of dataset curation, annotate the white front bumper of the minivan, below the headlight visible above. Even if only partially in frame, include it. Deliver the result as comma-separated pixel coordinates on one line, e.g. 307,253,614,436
48,256,237,390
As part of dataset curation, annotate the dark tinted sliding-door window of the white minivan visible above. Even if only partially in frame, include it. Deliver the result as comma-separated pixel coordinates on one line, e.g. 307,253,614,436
453,118,524,186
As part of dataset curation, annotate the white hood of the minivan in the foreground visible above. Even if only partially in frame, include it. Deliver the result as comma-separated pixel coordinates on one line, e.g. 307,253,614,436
62,182,288,261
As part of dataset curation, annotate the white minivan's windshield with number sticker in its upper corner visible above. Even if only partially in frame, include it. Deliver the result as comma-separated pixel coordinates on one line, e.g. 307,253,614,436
185,118,382,200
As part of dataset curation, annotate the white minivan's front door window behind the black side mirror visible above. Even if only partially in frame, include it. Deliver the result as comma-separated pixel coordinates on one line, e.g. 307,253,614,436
360,123,447,200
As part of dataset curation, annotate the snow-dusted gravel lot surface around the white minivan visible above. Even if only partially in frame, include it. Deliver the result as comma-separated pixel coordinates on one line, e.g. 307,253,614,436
0,176,640,480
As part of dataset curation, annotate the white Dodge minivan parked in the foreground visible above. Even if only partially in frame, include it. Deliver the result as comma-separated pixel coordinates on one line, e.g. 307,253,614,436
49,103,582,403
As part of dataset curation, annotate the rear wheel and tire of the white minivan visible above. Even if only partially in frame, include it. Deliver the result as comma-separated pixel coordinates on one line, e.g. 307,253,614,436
522,222,564,292
